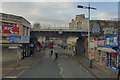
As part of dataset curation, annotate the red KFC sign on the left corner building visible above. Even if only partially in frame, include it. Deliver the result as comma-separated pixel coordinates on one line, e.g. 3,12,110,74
0,25,19,35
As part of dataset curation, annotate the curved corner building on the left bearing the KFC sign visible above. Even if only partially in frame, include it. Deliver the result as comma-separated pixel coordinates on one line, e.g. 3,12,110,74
0,13,31,58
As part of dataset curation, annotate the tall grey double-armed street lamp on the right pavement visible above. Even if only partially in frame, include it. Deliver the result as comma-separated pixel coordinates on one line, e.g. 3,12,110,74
77,3,96,68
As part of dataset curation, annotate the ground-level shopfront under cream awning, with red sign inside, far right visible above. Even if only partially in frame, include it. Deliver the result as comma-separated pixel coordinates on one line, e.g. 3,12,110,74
98,47,119,71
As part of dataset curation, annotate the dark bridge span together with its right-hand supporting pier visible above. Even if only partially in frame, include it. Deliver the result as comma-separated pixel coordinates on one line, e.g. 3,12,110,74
31,31,88,54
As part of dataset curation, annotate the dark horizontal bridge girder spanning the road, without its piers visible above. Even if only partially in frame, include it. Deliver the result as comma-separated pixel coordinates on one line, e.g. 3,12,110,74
31,31,87,38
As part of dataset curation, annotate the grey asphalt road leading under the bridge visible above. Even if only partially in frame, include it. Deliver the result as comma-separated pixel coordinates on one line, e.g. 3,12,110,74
18,47,94,78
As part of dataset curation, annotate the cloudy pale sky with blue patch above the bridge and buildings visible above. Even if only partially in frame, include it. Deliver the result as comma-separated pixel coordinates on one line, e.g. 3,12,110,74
0,2,118,26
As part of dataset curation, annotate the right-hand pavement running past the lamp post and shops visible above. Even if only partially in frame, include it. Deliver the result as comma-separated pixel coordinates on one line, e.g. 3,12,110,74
62,49,117,78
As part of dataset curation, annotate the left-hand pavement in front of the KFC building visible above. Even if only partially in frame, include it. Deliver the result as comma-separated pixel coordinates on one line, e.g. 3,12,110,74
2,51,44,78
